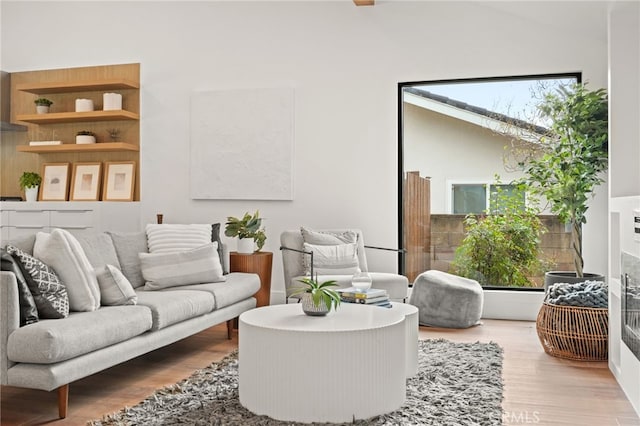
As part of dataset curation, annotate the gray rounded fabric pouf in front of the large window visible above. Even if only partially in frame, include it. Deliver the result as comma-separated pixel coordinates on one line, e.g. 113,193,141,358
409,270,484,328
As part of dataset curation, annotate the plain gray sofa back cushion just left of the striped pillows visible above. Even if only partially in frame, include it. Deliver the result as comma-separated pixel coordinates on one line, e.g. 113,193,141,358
107,231,149,288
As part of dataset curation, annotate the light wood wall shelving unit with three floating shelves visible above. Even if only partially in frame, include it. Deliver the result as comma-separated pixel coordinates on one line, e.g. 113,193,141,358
0,63,140,201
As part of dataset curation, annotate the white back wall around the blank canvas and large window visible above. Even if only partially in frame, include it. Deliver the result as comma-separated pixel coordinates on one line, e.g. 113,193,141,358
0,0,607,300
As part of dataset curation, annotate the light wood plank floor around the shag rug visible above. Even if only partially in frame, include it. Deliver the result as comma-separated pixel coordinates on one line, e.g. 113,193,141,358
0,320,640,426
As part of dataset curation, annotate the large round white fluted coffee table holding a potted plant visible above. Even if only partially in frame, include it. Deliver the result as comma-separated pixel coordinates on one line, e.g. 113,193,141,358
238,303,407,423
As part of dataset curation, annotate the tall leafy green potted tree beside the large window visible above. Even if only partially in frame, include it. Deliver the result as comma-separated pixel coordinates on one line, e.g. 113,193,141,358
524,83,608,278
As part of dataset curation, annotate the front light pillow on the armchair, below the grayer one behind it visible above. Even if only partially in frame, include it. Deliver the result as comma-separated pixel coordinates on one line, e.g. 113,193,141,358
303,243,360,275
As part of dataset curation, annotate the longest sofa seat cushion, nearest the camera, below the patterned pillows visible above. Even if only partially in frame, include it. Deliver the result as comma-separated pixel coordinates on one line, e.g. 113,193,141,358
7,306,151,364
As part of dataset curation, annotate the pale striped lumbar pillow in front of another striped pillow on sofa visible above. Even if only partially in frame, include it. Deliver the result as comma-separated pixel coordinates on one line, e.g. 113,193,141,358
139,243,225,290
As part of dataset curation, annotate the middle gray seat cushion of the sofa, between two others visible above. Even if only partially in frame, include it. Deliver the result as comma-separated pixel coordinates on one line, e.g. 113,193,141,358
136,289,215,330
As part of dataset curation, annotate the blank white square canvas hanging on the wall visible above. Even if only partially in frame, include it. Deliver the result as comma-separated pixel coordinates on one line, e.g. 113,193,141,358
190,88,294,200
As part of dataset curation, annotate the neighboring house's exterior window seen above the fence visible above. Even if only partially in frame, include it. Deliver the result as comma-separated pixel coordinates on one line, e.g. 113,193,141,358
451,183,525,214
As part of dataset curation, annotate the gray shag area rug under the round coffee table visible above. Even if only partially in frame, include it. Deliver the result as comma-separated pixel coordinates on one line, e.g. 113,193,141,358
88,339,502,426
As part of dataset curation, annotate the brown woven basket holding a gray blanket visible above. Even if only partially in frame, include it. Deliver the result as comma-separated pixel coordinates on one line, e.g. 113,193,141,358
536,302,609,361
